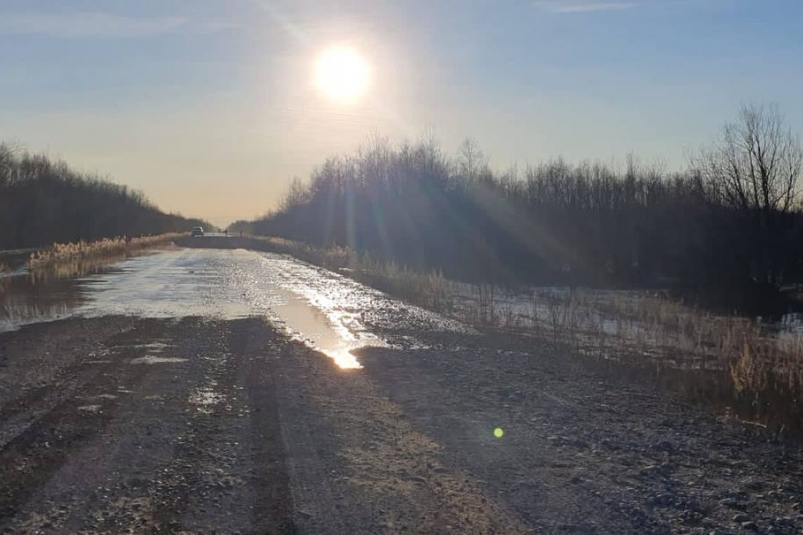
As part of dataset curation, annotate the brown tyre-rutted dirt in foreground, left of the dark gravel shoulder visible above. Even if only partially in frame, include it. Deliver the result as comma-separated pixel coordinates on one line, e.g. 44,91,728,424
0,318,520,533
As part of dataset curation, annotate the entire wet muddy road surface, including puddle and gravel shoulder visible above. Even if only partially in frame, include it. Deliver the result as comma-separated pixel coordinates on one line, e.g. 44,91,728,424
0,250,803,534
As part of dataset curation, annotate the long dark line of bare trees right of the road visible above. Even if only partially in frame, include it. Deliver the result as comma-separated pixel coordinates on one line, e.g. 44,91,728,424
247,105,803,312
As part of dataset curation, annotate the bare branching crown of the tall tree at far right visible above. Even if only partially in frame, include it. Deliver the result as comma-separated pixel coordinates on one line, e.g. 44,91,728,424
692,104,803,212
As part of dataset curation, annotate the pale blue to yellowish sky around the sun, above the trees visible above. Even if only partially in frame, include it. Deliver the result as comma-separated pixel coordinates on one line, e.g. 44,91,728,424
0,0,803,225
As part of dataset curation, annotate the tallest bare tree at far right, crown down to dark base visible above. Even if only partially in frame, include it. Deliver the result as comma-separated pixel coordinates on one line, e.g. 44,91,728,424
691,105,803,294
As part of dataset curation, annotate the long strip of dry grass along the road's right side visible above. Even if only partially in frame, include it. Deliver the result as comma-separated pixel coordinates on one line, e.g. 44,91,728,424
247,238,803,433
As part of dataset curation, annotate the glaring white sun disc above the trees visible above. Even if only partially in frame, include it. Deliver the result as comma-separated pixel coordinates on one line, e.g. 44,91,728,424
315,46,370,102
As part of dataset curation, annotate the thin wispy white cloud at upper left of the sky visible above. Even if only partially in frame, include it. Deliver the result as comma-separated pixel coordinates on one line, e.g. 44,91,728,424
0,12,239,39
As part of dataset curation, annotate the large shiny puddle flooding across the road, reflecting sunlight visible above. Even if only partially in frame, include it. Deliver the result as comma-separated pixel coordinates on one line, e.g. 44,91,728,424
0,249,396,368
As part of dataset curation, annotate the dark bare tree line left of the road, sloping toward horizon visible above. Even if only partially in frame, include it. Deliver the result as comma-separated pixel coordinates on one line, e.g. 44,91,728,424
0,144,210,250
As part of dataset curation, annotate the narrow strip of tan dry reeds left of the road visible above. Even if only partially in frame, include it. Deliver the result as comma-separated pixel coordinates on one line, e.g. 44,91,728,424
28,233,183,269
